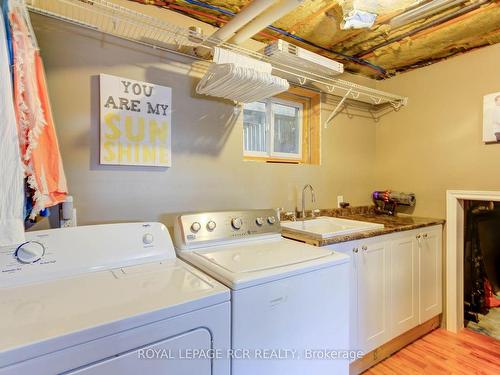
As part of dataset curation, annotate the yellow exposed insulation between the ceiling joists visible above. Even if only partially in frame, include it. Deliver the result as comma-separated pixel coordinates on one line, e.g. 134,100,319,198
132,0,500,78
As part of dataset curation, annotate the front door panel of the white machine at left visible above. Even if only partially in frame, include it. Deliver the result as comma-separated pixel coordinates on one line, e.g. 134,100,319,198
68,328,213,375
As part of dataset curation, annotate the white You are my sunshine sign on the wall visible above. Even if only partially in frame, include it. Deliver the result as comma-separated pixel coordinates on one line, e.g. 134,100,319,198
99,74,172,167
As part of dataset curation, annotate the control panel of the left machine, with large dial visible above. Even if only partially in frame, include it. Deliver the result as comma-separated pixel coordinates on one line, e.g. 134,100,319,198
0,223,176,288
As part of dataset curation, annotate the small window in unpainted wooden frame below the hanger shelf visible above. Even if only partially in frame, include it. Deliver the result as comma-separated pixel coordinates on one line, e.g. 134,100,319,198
243,88,319,164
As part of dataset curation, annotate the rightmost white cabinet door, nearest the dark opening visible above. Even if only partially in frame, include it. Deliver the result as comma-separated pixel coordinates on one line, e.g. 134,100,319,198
418,226,443,323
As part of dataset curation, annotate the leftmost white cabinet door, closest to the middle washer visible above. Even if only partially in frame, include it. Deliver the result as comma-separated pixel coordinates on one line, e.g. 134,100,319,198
356,240,390,353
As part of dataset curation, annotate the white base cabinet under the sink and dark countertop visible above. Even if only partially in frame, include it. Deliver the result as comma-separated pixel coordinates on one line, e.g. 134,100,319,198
329,225,442,353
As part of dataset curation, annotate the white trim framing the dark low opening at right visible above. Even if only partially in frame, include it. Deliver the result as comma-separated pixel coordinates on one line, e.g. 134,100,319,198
446,190,500,332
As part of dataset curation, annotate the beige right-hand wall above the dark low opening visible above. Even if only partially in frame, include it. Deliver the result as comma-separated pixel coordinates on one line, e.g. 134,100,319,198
374,44,500,217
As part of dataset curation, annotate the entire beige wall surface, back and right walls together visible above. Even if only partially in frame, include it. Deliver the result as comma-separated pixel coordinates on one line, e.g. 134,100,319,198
33,0,500,224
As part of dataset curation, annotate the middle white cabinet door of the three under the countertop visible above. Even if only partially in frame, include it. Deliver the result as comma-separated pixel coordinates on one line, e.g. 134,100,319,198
390,233,419,338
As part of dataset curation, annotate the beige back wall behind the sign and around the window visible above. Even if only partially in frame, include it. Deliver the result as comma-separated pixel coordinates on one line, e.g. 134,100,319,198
33,8,376,228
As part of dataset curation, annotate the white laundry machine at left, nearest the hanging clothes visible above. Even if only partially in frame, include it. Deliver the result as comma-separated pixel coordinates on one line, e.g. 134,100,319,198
0,223,231,375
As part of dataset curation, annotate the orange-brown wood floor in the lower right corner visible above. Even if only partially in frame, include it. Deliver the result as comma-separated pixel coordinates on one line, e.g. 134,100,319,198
364,329,500,375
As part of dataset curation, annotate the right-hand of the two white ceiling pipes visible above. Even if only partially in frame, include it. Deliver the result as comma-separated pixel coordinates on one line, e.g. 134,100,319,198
230,0,304,44
